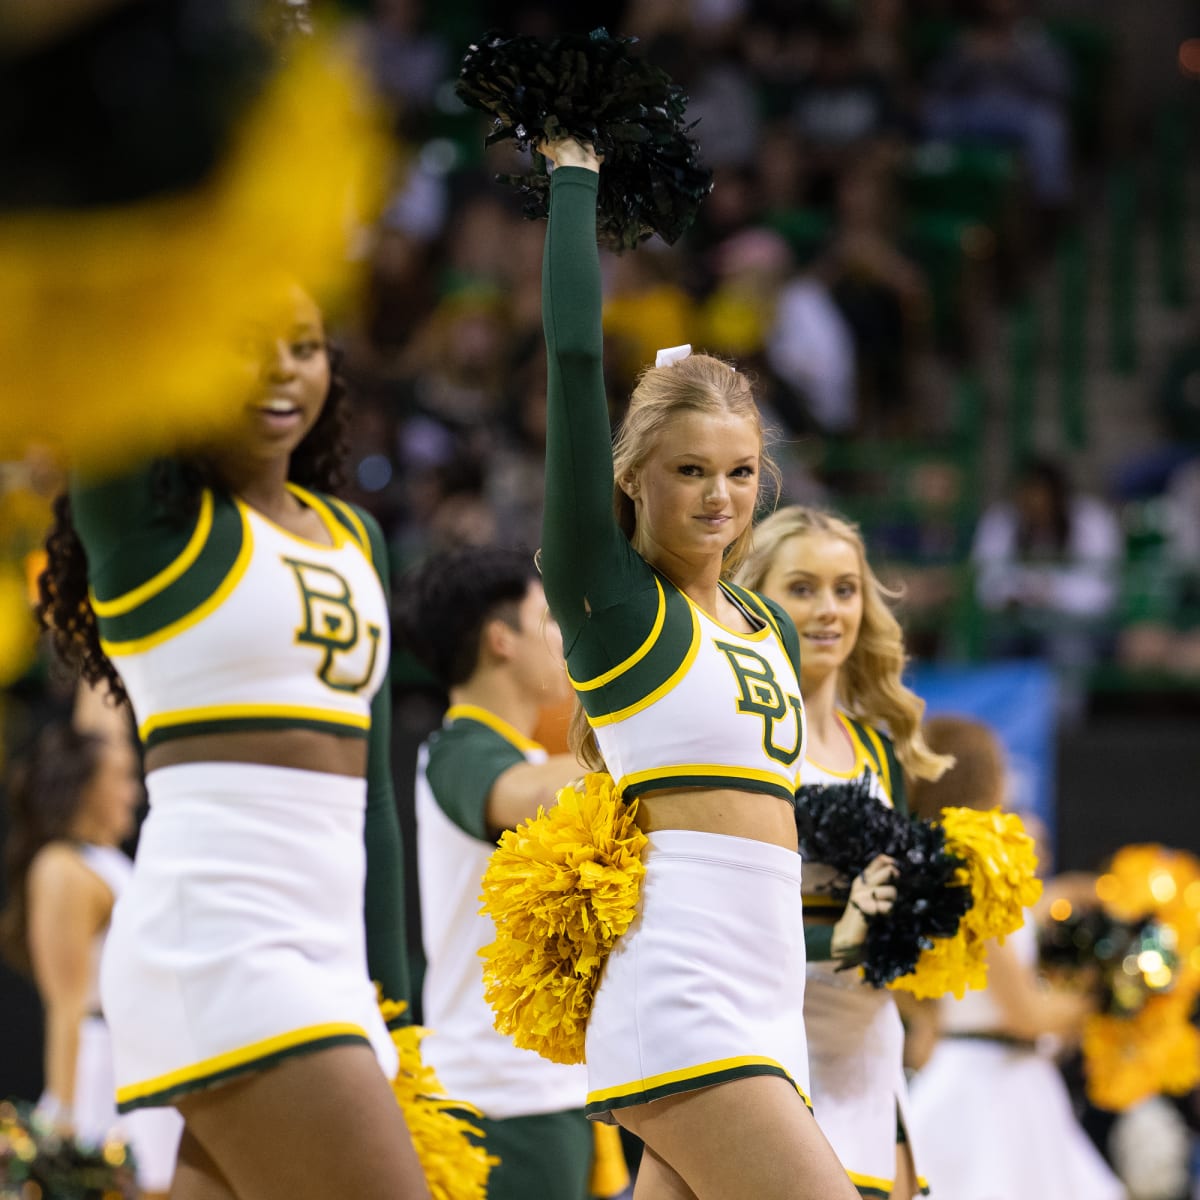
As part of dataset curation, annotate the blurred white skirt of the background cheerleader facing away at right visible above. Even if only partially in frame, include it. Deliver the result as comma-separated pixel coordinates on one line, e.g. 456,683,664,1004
912,1038,1126,1200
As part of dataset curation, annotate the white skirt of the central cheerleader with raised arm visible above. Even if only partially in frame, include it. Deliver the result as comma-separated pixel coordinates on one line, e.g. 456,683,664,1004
587,829,809,1124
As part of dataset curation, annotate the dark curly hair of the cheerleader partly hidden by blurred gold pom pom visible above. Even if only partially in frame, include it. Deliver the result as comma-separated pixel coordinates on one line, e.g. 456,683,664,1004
36,348,349,704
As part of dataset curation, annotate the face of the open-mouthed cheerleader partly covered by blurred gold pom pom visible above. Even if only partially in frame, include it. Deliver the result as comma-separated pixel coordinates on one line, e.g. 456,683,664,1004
226,287,330,461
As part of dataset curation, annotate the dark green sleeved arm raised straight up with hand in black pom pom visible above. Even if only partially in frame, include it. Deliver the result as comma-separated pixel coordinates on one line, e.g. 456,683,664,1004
541,147,644,648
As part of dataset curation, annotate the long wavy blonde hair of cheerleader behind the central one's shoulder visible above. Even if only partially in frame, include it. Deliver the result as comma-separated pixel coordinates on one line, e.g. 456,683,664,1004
738,505,954,780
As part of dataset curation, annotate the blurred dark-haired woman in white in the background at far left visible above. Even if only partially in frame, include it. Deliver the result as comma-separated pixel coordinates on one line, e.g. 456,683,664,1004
0,709,182,1200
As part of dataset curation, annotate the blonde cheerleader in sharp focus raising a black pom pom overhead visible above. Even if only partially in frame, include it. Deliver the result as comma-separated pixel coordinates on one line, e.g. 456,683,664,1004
532,138,854,1200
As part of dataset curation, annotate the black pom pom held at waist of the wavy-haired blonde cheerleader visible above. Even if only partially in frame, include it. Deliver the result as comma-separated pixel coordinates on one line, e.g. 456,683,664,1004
796,772,971,988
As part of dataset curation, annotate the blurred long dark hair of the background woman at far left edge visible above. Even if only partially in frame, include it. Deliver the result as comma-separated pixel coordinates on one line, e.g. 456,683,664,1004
0,722,104,974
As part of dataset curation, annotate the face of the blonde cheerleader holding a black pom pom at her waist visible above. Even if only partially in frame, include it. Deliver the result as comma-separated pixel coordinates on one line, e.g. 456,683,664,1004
760,533,863,689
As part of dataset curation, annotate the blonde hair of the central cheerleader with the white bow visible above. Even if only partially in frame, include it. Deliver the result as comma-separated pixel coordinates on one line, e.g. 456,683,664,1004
568,354,779,770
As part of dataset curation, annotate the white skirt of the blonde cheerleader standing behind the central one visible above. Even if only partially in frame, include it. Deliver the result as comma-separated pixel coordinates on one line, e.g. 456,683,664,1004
804,962,926,1196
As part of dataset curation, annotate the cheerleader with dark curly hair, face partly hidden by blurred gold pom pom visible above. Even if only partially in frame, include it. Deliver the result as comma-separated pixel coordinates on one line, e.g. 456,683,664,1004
40,288,428,1200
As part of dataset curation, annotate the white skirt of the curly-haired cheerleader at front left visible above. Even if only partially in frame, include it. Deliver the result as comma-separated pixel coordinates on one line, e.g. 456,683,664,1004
101,763,397,1112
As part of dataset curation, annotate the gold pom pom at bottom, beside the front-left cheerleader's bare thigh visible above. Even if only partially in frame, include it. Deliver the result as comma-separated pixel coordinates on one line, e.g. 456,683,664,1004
379,1000,499,1200
